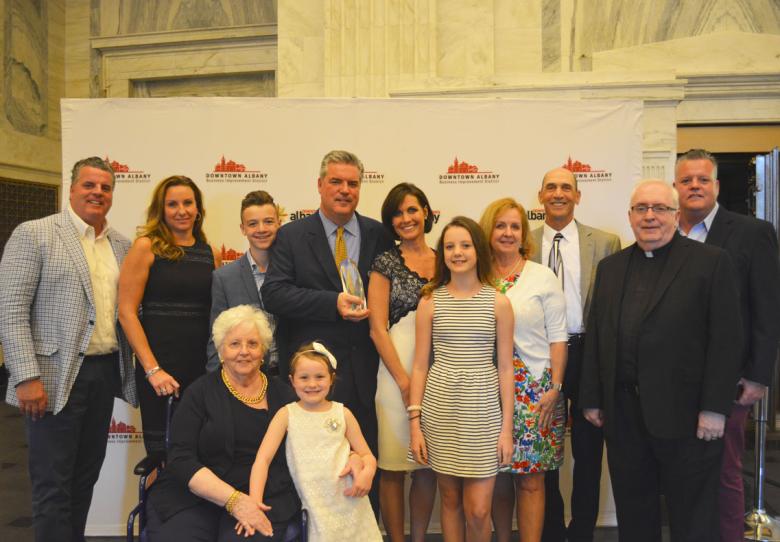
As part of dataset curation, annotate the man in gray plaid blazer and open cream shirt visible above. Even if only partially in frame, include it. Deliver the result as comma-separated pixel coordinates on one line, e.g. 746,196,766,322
0,157,136,541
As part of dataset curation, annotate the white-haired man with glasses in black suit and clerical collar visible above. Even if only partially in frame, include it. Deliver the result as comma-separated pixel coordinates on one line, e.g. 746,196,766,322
580,180,742,542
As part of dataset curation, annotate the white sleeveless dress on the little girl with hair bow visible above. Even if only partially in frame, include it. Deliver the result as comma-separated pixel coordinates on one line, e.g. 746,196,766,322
285,401,382,542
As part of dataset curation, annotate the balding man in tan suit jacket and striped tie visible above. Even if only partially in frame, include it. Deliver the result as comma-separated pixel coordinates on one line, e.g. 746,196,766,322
531,168,620,542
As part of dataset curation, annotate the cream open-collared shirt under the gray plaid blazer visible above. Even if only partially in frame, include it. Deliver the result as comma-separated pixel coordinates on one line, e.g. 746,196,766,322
68,206,119,356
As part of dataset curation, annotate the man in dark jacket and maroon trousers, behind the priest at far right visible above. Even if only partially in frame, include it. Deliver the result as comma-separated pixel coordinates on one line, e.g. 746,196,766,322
674,149,780,542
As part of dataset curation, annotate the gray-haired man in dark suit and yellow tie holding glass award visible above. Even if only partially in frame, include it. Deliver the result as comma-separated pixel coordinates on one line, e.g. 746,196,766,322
261,151,392,509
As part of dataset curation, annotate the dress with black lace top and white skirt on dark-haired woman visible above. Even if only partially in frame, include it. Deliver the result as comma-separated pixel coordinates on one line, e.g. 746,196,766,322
371,247,428,471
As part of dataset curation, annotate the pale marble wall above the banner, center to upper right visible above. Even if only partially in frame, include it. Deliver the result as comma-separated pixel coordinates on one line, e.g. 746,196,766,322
277,0,780,184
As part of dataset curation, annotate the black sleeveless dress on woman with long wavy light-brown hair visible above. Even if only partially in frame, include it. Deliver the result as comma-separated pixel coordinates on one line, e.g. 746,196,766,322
135,241,214,452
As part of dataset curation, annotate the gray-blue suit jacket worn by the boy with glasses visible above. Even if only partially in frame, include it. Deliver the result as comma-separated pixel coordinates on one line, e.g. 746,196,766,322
206,251,262,371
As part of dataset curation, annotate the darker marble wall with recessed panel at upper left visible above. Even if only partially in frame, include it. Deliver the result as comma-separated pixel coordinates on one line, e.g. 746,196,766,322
0,0,277,184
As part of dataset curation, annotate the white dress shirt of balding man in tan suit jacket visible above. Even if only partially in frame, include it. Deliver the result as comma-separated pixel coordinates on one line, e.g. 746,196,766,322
541,220,585,334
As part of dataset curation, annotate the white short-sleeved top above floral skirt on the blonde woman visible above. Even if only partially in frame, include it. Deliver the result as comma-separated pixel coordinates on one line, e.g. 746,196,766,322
505,260,569,379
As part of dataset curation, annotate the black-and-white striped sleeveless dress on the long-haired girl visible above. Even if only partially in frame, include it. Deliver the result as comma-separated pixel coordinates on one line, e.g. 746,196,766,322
420,286,501,478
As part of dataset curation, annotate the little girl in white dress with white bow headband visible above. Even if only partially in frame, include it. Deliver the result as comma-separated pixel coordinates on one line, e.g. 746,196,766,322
249,342,382,542
